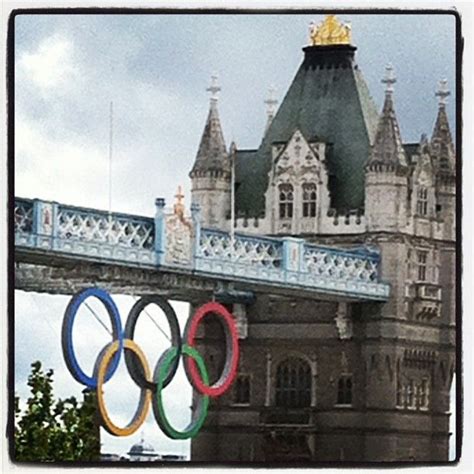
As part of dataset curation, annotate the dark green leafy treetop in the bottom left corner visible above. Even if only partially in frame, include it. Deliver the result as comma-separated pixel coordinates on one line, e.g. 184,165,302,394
14,361,100,462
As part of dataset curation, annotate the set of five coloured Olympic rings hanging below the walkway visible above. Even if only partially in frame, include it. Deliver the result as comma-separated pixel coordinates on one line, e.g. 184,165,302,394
62,288,239,439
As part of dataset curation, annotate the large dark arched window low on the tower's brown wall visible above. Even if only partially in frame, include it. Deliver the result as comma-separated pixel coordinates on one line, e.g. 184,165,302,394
275,357,311,408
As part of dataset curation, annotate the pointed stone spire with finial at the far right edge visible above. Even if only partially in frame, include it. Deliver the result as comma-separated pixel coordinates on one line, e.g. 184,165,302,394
431,80,455,173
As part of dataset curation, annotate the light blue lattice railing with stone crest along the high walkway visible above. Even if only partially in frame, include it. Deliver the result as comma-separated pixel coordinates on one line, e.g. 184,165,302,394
15,198,389,300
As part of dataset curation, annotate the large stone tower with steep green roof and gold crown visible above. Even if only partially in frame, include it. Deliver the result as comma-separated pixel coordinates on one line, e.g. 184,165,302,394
191,15,455,463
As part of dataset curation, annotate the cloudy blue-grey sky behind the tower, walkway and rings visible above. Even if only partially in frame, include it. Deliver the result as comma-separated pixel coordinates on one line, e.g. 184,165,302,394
15,14,455,462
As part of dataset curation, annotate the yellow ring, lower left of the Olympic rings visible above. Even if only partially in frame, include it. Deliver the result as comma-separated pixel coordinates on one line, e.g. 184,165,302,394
95,339,151,436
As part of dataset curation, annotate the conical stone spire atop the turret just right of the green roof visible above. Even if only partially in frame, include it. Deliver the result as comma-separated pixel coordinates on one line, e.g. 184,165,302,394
368,65,407,169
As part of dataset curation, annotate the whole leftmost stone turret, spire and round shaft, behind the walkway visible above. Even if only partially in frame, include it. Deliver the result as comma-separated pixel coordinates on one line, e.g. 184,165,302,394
189,76,231,227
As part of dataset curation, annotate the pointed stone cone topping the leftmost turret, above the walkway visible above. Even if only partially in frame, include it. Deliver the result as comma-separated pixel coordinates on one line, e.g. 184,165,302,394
190,74,230,177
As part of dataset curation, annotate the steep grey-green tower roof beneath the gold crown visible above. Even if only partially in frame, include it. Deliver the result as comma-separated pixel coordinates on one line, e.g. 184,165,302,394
236,45,377,216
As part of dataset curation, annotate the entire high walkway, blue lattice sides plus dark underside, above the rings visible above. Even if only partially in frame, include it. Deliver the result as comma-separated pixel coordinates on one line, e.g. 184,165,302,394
15,198,389,301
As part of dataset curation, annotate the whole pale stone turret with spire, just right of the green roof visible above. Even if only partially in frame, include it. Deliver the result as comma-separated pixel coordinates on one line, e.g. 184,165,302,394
365,66,408,231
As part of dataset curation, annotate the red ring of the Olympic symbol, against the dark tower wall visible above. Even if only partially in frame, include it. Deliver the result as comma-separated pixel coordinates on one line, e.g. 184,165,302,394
184,302,239,397
